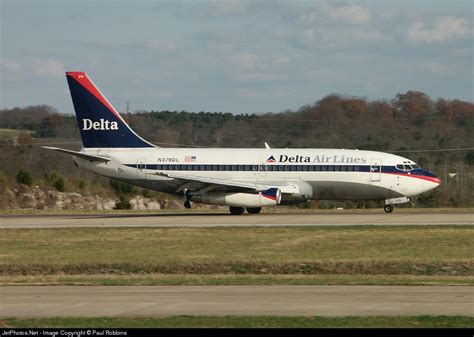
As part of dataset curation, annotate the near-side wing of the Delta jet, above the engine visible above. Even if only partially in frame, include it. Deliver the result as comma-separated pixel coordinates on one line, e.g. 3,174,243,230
156,172,270,193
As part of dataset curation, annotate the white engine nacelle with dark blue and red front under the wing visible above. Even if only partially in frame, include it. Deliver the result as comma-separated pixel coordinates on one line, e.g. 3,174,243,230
191,188,281,207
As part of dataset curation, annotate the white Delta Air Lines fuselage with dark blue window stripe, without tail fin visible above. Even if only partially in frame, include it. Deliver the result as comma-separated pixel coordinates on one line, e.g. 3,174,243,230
75,148,439,200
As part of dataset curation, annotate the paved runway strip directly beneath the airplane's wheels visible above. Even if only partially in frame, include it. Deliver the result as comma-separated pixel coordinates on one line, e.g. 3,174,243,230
0,211,474,228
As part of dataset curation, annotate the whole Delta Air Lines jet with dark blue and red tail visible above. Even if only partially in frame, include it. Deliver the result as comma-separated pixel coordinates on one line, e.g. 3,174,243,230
45,71,441,215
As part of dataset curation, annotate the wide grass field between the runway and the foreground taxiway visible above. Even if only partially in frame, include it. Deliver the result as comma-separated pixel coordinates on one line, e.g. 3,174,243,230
0,226,474,285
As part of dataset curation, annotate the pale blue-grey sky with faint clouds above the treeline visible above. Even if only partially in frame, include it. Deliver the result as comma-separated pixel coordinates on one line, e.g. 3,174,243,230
0,0,474,113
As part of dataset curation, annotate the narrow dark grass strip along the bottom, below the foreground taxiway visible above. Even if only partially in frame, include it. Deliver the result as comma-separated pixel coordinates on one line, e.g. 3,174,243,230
0,316,474,328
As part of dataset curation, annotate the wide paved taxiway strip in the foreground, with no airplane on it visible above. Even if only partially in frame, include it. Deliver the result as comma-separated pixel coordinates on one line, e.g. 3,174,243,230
0,285,474,317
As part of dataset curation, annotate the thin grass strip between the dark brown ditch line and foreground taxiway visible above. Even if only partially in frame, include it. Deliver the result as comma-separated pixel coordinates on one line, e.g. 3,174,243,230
0,274,474,286
